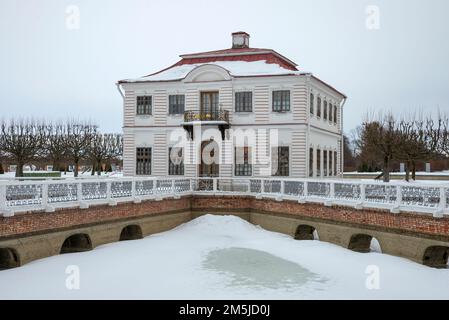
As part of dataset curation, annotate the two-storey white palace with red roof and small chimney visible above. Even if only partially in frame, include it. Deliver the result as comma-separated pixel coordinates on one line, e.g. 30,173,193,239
117,32,346,178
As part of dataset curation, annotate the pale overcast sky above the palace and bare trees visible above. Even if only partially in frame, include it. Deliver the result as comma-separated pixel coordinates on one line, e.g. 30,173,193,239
0,0,449,132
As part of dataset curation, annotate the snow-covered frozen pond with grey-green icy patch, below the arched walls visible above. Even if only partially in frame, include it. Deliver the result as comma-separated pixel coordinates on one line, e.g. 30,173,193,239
0,215,449,299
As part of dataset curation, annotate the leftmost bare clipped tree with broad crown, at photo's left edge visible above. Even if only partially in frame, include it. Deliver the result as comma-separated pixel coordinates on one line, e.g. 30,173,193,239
0,119,45,177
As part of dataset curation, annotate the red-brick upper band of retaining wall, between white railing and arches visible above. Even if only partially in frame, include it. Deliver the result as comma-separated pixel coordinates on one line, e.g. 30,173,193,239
0,196,449,239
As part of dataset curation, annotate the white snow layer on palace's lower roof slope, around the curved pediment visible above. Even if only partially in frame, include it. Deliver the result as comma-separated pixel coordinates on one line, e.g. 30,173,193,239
123,60,307,82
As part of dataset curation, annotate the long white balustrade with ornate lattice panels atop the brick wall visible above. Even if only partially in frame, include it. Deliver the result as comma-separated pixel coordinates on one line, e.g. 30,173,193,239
0,177,449,217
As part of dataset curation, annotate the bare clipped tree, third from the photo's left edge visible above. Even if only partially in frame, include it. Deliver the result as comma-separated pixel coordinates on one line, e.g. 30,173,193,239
66,120,97,177
